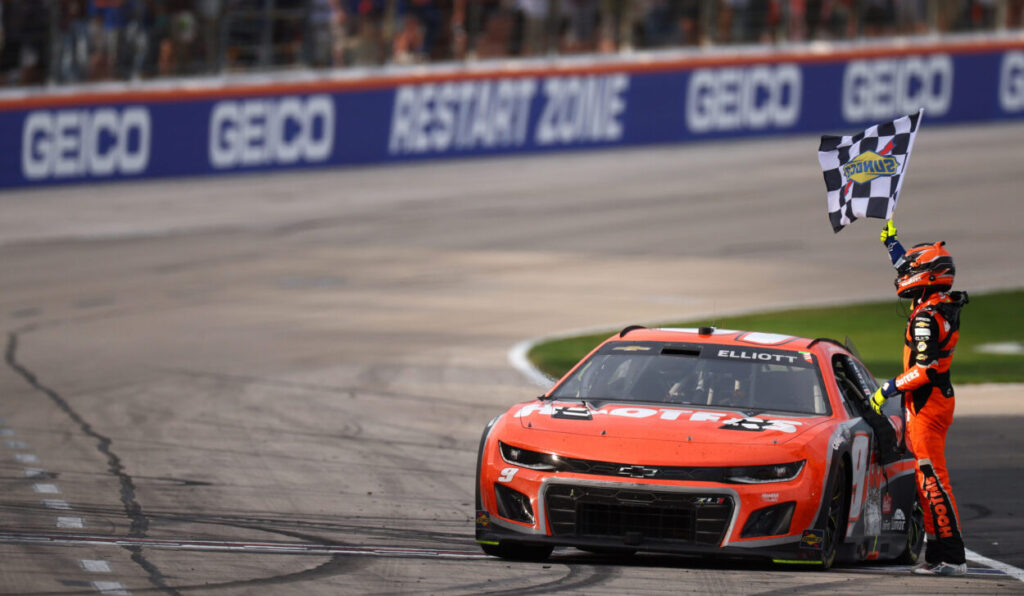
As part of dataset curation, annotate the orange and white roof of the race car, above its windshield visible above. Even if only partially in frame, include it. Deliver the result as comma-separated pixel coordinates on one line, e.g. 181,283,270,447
606,326,846,351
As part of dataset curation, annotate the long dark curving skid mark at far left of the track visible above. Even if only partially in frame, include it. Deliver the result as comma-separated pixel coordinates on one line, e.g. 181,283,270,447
4,332,178,595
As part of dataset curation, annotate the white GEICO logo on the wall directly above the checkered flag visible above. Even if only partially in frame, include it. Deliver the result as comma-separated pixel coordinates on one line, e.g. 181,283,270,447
843,53,953,122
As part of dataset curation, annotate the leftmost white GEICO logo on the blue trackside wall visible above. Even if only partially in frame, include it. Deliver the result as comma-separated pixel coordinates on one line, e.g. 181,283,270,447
22,105,153,180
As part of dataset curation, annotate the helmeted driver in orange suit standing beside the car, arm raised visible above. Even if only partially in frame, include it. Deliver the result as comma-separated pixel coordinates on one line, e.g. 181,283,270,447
871,220,968,576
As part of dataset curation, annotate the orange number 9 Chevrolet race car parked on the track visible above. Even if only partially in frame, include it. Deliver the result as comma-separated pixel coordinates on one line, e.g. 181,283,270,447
476,327,924,568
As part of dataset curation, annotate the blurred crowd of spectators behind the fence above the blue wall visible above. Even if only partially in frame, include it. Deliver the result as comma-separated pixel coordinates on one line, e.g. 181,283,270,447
0,0,1024,85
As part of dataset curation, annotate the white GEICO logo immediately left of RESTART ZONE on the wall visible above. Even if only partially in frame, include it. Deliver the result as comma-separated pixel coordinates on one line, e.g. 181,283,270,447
208,95,335,170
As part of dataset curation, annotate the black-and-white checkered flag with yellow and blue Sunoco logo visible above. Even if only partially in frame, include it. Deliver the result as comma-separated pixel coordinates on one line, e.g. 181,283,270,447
818,110,925,232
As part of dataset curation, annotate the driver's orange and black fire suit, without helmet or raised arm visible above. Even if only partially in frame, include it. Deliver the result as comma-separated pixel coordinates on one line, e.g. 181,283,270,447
895,292,967,564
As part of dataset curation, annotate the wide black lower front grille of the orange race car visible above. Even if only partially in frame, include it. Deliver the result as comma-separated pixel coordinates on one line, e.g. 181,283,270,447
545,484,733,546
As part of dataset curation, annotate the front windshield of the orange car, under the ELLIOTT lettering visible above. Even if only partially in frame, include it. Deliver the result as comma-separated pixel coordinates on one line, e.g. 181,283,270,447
551,342,831,415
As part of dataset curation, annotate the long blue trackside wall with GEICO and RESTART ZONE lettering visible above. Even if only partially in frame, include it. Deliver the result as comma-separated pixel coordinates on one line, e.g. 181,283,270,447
0,42,1024,187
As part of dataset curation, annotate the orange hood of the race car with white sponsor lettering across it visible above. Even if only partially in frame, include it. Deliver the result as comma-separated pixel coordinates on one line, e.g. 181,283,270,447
512,401,829,445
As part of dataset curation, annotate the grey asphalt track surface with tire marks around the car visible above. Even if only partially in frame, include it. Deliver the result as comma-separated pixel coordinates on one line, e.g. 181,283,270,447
0,124,1024,594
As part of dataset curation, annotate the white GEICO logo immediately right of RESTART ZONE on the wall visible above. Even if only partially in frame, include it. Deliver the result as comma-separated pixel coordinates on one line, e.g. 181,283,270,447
686,63,803,134
